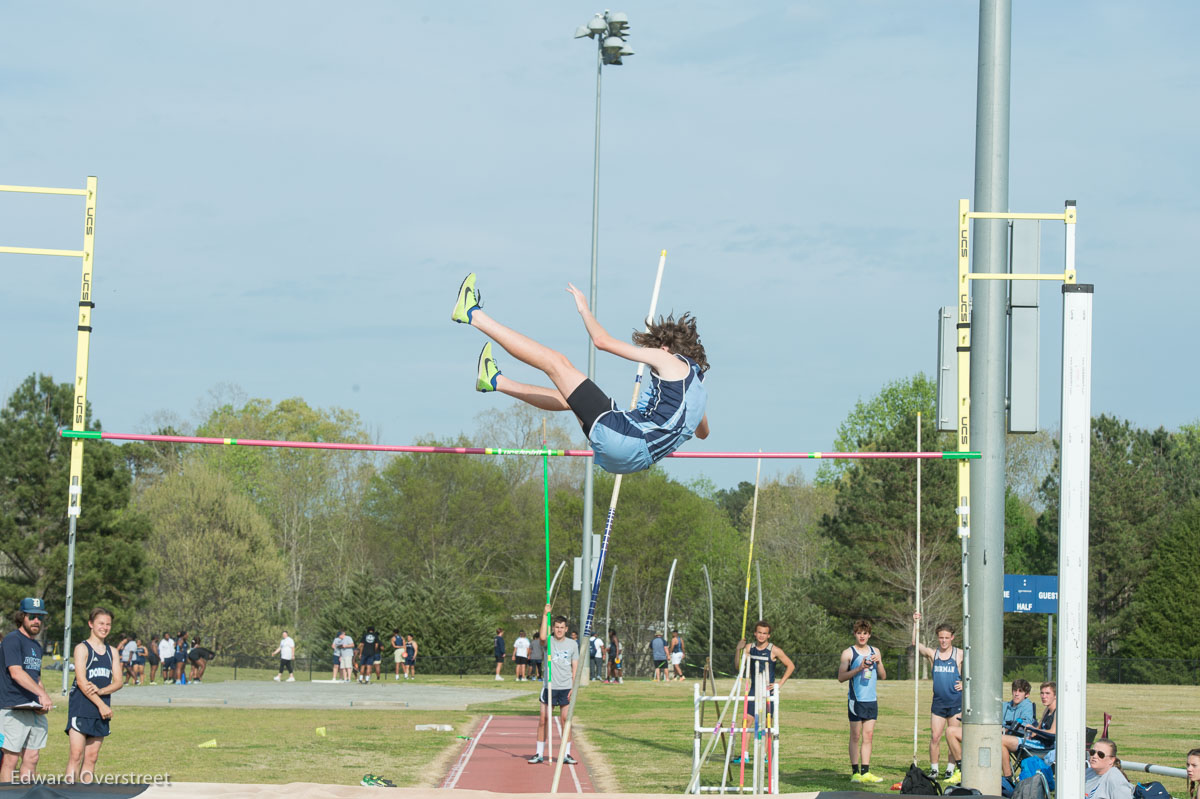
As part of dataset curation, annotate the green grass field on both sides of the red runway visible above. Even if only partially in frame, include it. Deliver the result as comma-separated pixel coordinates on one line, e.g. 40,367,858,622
21,669,1200,793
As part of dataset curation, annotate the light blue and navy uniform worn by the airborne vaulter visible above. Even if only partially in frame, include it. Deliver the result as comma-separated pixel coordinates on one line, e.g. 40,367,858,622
588,353,708,474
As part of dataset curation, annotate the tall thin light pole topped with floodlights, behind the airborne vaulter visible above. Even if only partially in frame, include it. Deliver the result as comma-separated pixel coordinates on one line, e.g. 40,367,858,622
575,11,634,684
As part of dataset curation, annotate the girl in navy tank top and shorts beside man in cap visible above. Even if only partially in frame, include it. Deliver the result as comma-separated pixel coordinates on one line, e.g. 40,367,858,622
66,607,124,782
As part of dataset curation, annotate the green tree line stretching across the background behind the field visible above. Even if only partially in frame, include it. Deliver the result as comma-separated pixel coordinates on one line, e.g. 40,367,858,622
0,374,1200,679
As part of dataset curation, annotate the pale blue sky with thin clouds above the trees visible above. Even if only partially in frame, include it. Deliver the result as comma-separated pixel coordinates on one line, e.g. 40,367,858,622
0,0,1200,486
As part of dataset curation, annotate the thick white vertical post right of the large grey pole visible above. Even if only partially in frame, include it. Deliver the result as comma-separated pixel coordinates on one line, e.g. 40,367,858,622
1057,203,1092,797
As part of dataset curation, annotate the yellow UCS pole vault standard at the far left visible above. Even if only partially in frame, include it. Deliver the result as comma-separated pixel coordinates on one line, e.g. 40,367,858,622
0,176,96,693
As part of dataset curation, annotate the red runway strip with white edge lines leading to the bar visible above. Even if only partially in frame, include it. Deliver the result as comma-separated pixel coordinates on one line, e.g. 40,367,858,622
438,716,596,793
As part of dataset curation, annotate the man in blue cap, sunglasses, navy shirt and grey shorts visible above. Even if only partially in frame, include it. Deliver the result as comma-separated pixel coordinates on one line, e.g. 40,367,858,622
0,596,50,782
